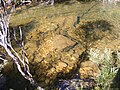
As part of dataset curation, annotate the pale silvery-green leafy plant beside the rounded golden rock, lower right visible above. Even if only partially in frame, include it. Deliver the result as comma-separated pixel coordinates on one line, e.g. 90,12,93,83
89,48,120,90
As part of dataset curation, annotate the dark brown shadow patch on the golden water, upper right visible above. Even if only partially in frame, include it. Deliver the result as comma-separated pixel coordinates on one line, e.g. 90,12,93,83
75,20,114,49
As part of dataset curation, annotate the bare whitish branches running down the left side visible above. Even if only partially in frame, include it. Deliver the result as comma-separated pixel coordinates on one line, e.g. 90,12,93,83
0,0,44,90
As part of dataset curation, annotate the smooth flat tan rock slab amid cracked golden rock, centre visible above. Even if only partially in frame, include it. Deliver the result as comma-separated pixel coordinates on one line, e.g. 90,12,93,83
41,35,75,57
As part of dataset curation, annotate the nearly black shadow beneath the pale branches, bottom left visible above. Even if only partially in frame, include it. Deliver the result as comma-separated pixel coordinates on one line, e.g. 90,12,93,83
6,67,35,90
